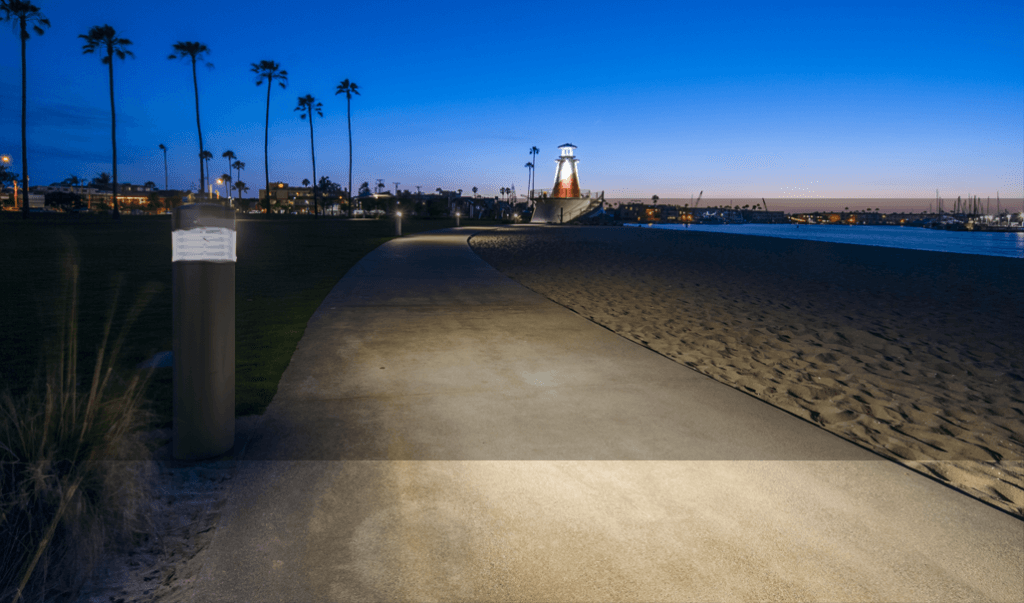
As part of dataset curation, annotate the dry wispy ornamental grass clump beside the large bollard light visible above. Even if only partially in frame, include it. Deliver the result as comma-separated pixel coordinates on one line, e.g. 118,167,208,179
0,245,156,601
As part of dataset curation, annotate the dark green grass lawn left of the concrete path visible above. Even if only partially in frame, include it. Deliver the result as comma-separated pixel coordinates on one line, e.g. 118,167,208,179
0,214,495,427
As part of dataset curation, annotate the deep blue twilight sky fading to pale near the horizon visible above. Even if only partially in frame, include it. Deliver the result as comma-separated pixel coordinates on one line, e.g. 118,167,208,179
0,0,1024,209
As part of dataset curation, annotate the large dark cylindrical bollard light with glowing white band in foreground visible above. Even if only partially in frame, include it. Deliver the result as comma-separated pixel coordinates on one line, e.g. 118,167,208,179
171,203,236,461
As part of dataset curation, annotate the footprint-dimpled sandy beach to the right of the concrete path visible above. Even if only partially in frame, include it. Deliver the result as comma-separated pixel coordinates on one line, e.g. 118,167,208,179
470,223,1024,517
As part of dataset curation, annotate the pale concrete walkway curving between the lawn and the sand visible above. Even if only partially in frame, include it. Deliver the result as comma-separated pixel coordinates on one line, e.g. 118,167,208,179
194,229,1024,602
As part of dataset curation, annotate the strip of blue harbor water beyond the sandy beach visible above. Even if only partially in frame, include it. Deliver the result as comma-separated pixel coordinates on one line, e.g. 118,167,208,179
629,224,1024,258
